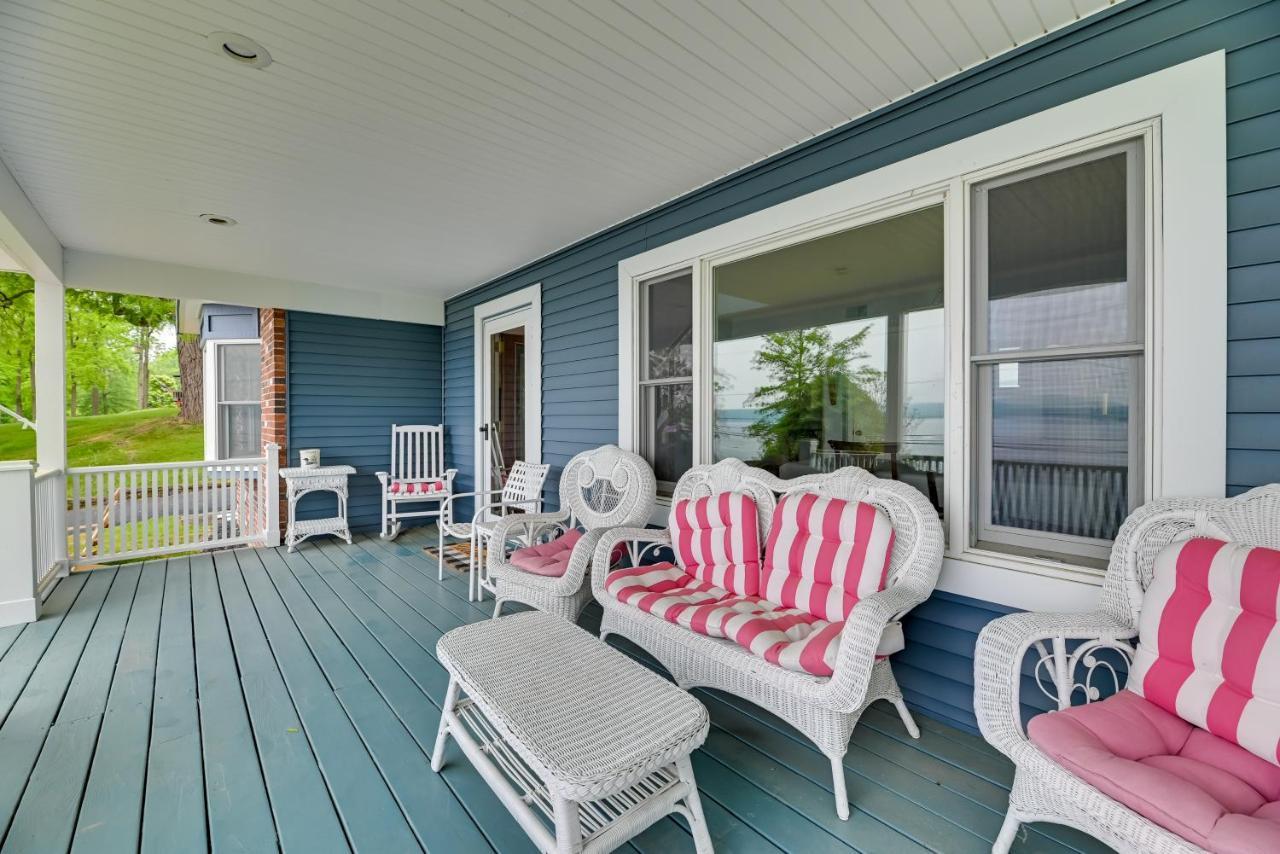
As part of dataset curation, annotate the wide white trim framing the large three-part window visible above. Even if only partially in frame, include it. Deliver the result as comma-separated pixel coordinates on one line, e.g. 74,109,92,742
618,51,1226,611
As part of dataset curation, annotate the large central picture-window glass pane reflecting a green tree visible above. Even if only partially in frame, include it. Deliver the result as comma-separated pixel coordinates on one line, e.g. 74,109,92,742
713,206,945,507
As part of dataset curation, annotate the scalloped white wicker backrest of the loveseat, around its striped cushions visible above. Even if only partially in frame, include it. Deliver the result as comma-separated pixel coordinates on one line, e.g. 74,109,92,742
672,460,942,599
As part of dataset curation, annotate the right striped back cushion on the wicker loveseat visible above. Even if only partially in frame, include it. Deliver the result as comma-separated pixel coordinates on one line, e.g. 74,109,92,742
760,493,893,620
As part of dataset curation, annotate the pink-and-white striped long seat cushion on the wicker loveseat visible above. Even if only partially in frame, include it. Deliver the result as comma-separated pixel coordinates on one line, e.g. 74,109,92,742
605,563,845,676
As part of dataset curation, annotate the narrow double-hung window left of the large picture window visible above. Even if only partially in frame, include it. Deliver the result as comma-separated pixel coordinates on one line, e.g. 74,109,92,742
640,270,694,495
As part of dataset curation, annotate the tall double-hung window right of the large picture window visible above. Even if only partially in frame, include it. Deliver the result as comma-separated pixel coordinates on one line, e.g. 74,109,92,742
970,143,1146,562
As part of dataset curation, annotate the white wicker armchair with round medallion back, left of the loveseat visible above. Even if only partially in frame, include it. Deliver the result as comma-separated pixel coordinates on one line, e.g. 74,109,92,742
488,444,657,621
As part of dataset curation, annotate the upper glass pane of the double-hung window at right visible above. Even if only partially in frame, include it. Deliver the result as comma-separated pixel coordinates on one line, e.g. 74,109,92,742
982,151,1142,352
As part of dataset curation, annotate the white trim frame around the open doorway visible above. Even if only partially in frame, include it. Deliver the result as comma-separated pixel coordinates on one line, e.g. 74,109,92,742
471,282,543,489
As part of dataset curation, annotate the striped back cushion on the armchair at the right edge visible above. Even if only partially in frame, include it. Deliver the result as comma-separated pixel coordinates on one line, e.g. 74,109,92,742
1129,539,1280,764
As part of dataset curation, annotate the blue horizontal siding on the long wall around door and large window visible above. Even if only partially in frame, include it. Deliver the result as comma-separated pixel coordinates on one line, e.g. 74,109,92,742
444,0,1280,729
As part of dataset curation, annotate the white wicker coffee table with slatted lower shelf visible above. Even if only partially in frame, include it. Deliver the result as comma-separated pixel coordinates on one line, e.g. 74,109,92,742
431,611,712,853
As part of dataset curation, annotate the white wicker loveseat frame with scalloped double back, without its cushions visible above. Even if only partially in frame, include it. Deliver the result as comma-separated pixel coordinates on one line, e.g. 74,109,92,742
591,460,942,819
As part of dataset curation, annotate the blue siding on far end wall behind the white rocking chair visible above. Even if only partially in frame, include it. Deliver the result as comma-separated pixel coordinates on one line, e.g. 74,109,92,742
285,311,444,530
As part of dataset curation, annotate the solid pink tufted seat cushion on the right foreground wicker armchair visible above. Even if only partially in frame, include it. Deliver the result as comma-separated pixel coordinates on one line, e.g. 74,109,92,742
1027,690,1280,854
